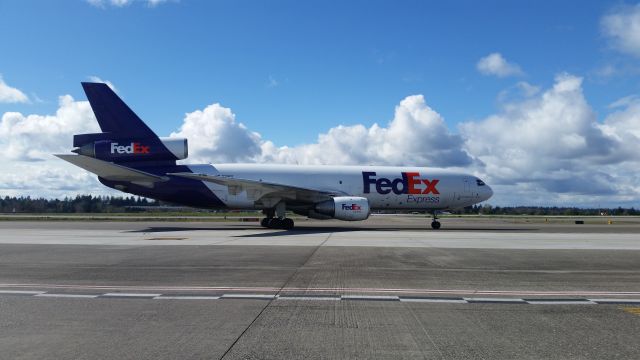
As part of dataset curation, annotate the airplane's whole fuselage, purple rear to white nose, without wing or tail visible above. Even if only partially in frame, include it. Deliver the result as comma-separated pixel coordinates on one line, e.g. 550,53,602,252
101,164,493,211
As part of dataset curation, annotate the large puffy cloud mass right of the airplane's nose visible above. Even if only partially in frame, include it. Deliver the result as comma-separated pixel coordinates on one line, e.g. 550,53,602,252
460,74,640,204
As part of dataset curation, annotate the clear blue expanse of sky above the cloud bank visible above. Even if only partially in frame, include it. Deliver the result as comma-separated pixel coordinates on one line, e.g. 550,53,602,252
0,0,638,145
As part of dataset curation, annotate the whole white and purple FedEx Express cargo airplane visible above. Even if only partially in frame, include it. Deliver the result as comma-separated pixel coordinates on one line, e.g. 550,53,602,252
56,83,493,229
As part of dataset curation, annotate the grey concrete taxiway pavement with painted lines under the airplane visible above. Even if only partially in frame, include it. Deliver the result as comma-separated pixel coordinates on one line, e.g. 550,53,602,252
0,217,640,359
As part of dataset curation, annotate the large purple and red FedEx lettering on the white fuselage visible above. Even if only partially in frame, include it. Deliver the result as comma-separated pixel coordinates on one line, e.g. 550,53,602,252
362,171,440,195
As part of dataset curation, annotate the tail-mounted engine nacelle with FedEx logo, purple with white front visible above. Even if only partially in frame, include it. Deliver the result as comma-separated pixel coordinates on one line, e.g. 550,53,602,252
74,138,189,161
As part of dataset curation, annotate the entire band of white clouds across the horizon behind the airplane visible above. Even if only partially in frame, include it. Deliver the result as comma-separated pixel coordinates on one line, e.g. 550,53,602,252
0,74,640,206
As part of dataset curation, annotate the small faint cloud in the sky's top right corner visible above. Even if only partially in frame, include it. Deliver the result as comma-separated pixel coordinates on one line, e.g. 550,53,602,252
600,4,640,56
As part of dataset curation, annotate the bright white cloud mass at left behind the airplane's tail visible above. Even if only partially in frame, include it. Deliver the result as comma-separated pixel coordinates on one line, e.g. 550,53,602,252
0,95,115,198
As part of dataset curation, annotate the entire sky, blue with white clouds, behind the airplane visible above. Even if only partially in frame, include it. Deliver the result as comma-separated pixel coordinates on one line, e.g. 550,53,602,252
0,0,640,207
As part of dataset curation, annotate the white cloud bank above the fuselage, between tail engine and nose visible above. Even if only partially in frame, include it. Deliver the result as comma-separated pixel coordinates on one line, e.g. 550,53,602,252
171,95,472,167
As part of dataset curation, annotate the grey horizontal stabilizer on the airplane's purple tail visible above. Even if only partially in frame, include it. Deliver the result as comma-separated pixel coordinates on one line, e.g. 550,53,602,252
55,154,168,187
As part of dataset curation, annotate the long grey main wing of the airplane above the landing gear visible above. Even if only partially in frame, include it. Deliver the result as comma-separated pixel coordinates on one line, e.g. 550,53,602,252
167,173,346,202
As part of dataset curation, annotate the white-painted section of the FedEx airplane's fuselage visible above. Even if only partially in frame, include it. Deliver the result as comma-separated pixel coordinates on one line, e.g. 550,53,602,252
188,164,493,210
